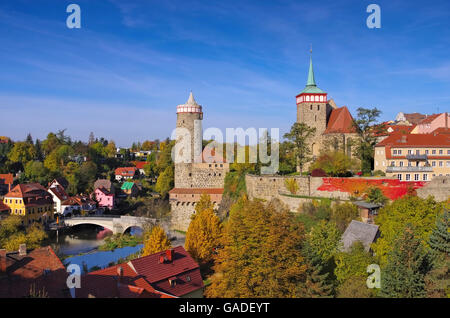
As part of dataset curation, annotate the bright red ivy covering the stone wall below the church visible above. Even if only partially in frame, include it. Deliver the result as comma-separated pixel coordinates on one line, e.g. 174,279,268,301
317,178,426,200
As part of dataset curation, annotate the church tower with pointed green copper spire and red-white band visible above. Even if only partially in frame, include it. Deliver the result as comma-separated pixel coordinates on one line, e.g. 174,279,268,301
296,56,332,156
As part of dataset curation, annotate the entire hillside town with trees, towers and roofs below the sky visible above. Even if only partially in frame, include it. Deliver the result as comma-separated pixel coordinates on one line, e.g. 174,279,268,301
0,53,450,298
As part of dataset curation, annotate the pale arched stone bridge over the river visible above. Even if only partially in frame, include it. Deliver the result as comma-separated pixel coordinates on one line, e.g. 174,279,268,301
64,216,156,234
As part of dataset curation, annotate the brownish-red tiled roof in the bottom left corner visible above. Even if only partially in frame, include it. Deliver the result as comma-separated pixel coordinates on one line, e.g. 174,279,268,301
0,246,68,298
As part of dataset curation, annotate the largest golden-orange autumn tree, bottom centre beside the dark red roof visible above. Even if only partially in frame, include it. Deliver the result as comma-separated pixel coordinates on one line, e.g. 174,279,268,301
206,196,306,297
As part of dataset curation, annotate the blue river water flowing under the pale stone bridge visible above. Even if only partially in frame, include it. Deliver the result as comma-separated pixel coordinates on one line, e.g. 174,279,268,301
46,225,184,270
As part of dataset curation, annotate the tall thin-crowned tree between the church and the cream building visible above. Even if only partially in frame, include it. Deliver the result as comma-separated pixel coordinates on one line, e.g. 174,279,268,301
353,107,382,173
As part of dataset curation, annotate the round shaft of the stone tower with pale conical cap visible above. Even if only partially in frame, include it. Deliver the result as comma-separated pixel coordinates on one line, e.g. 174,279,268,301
175,92,203,188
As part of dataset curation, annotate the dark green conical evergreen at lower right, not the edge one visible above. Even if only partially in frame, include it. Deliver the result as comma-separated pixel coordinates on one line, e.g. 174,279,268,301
380,224,429,298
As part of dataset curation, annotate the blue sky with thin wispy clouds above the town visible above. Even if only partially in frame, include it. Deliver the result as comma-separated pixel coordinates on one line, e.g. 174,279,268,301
0,0,450,146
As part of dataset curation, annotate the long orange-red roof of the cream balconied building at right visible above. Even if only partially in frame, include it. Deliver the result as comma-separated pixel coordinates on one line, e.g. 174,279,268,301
376,134,450,148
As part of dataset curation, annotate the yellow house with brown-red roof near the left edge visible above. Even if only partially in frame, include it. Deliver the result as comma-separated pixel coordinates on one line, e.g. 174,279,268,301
3,183,54,226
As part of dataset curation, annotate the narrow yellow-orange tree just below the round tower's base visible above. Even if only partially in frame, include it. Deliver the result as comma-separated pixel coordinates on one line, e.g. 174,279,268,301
184,194,222,263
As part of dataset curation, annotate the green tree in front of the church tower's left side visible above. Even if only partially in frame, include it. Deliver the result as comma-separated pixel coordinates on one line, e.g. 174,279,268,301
284,123,316,174
